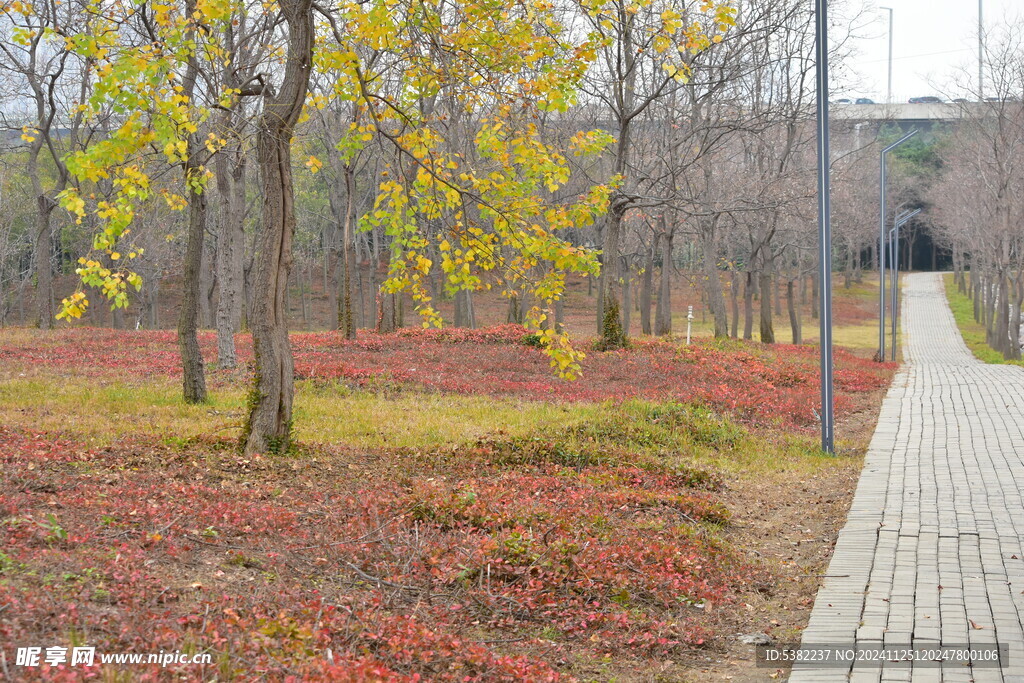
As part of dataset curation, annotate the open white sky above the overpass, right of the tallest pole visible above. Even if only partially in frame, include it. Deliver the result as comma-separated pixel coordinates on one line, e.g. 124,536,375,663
833,0,1024,102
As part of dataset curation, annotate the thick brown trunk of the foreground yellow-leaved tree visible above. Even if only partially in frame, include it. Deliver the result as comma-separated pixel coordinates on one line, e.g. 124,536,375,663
243,0,314,454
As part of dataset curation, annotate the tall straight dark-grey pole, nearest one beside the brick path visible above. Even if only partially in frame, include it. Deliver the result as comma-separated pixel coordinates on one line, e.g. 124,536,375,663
814,0,836,453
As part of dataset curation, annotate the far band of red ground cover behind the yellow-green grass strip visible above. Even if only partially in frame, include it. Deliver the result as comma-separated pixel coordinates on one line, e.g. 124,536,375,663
0,325,894,429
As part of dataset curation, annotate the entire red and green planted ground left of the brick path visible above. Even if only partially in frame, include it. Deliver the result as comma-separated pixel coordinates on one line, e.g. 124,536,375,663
0,323,894,681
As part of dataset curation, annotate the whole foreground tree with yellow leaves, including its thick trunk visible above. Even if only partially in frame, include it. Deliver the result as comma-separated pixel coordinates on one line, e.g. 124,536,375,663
54,0,731,453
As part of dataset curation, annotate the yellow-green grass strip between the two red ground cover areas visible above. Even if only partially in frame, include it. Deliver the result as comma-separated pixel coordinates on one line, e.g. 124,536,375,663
0,366,843,483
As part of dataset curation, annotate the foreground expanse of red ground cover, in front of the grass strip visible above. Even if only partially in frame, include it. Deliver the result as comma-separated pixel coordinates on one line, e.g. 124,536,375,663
0,427,765,681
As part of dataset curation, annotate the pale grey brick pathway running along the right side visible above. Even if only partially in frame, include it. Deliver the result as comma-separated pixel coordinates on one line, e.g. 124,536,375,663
790,273,1024,683
